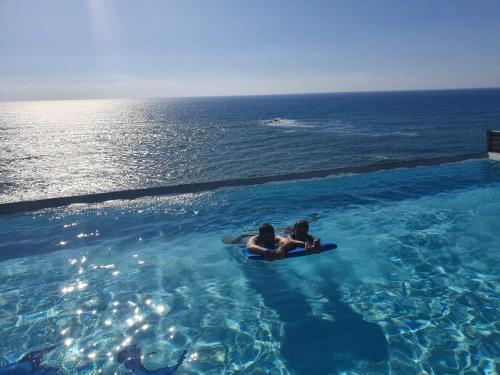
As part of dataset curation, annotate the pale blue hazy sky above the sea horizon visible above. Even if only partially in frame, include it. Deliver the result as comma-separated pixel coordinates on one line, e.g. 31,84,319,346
0,0,500,100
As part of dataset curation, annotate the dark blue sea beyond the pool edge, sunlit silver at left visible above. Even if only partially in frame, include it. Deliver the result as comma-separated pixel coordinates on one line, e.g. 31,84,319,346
0,89,500,203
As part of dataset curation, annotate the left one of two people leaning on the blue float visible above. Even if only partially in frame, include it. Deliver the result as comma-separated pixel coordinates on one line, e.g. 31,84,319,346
247,223,297,261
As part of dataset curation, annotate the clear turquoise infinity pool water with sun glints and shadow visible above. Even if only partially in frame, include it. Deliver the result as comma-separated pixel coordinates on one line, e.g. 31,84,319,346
0,160,500,375
